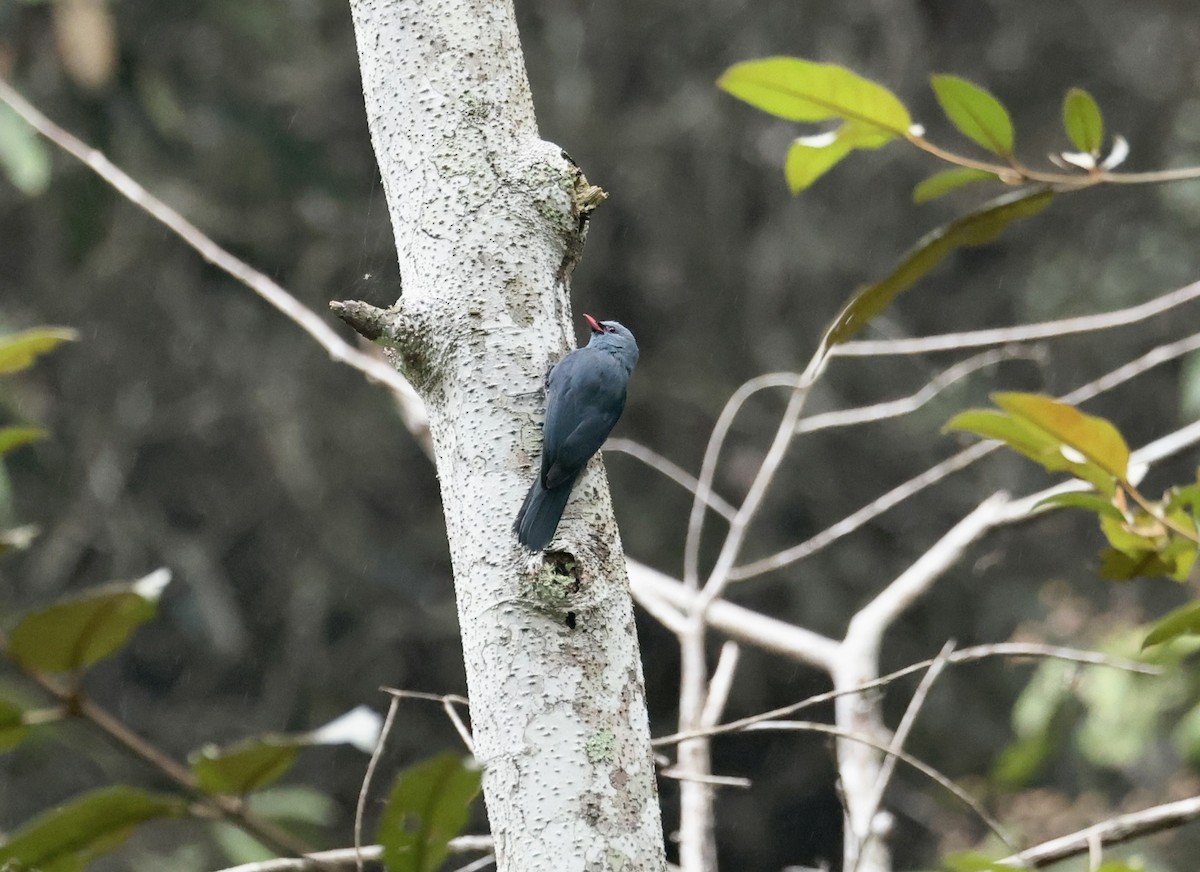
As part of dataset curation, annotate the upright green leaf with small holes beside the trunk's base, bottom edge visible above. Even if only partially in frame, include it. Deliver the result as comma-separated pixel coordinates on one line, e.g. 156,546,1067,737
379,752,480,872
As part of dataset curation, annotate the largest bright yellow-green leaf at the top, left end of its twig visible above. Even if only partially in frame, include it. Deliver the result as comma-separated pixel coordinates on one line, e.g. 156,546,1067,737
716,58,912,137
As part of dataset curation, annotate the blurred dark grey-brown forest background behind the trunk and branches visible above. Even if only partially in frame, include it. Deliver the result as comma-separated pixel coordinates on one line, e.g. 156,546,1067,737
0,0,1200,871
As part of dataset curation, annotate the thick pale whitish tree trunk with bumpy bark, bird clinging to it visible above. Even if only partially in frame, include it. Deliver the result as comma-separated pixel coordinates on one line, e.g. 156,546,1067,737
337,0,665,872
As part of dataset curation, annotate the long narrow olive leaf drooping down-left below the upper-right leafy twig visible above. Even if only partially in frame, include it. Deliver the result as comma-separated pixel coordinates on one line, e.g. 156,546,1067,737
824,187,1054,347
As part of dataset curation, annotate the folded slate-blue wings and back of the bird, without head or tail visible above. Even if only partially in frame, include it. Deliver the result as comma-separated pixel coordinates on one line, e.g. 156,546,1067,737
541,349,629,488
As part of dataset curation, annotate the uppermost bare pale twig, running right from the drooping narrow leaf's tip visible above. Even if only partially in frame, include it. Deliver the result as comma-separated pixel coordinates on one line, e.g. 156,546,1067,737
832,282,1200,357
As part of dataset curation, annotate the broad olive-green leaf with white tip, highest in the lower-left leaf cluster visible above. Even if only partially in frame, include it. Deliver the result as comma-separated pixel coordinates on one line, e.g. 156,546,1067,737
8,570,170,672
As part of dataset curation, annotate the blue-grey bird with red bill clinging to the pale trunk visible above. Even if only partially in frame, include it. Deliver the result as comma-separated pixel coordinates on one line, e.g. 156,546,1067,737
514,315,637,551
